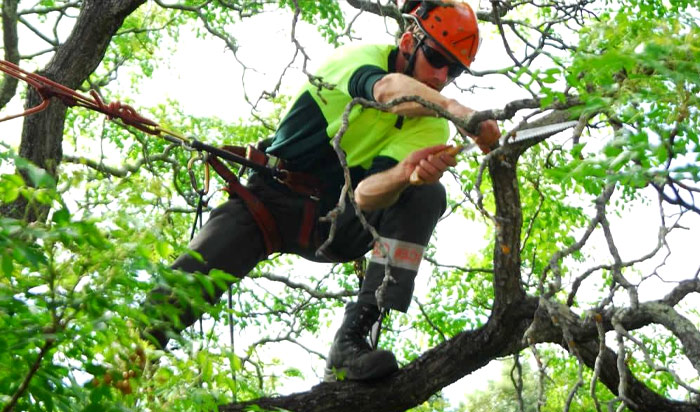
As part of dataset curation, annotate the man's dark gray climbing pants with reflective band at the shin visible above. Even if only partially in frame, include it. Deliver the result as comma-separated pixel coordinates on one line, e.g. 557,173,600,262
147,174,446,345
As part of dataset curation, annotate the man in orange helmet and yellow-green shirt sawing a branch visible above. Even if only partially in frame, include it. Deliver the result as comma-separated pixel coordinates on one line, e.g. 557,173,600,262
149,1,500,380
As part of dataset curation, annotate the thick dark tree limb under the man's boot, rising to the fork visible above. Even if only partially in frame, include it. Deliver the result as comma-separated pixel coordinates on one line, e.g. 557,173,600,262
219,300,536,412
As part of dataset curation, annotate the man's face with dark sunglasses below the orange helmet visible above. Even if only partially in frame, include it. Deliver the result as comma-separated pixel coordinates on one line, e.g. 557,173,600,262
413,38,464,91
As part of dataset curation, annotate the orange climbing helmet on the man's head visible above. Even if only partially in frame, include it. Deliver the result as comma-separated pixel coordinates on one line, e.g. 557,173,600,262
398,0,480,68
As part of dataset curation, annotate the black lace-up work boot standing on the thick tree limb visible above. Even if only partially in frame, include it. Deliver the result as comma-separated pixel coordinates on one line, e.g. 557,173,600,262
323,303,399,382
